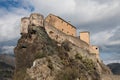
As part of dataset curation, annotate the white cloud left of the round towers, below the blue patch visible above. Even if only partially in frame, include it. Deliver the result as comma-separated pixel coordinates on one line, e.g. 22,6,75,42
0,13,25,42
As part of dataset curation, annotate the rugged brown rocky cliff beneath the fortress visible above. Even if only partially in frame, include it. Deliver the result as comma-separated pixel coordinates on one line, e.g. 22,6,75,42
14,13,111,80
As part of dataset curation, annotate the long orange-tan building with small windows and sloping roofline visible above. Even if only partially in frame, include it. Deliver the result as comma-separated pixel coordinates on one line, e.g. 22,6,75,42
45,14,76,36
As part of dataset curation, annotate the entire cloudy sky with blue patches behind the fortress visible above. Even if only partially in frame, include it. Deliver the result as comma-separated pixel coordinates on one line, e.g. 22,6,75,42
0,0,120,63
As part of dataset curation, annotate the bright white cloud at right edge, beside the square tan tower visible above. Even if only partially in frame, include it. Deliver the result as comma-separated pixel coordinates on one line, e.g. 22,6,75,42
91,26,120,46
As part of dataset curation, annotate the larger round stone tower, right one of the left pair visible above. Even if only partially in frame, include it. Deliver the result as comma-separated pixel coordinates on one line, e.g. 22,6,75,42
30,13,44,27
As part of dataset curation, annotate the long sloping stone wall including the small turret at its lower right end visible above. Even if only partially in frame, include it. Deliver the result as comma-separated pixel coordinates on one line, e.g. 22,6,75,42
44,22,100,60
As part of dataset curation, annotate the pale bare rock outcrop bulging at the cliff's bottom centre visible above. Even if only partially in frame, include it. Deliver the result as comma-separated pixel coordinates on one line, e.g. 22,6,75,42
27,55,64,80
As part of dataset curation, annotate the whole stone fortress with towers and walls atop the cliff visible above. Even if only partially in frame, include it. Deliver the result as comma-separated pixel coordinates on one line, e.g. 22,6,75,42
21,13,99,59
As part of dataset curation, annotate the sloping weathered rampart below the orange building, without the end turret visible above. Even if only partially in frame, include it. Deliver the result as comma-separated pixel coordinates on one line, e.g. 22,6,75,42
45,22,89,50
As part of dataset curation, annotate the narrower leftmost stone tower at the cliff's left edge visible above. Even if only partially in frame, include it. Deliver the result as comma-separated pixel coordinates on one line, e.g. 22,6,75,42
20,17,30,33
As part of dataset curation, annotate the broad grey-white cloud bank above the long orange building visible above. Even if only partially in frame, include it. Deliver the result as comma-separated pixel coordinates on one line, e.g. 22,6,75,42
28,0,120,33
